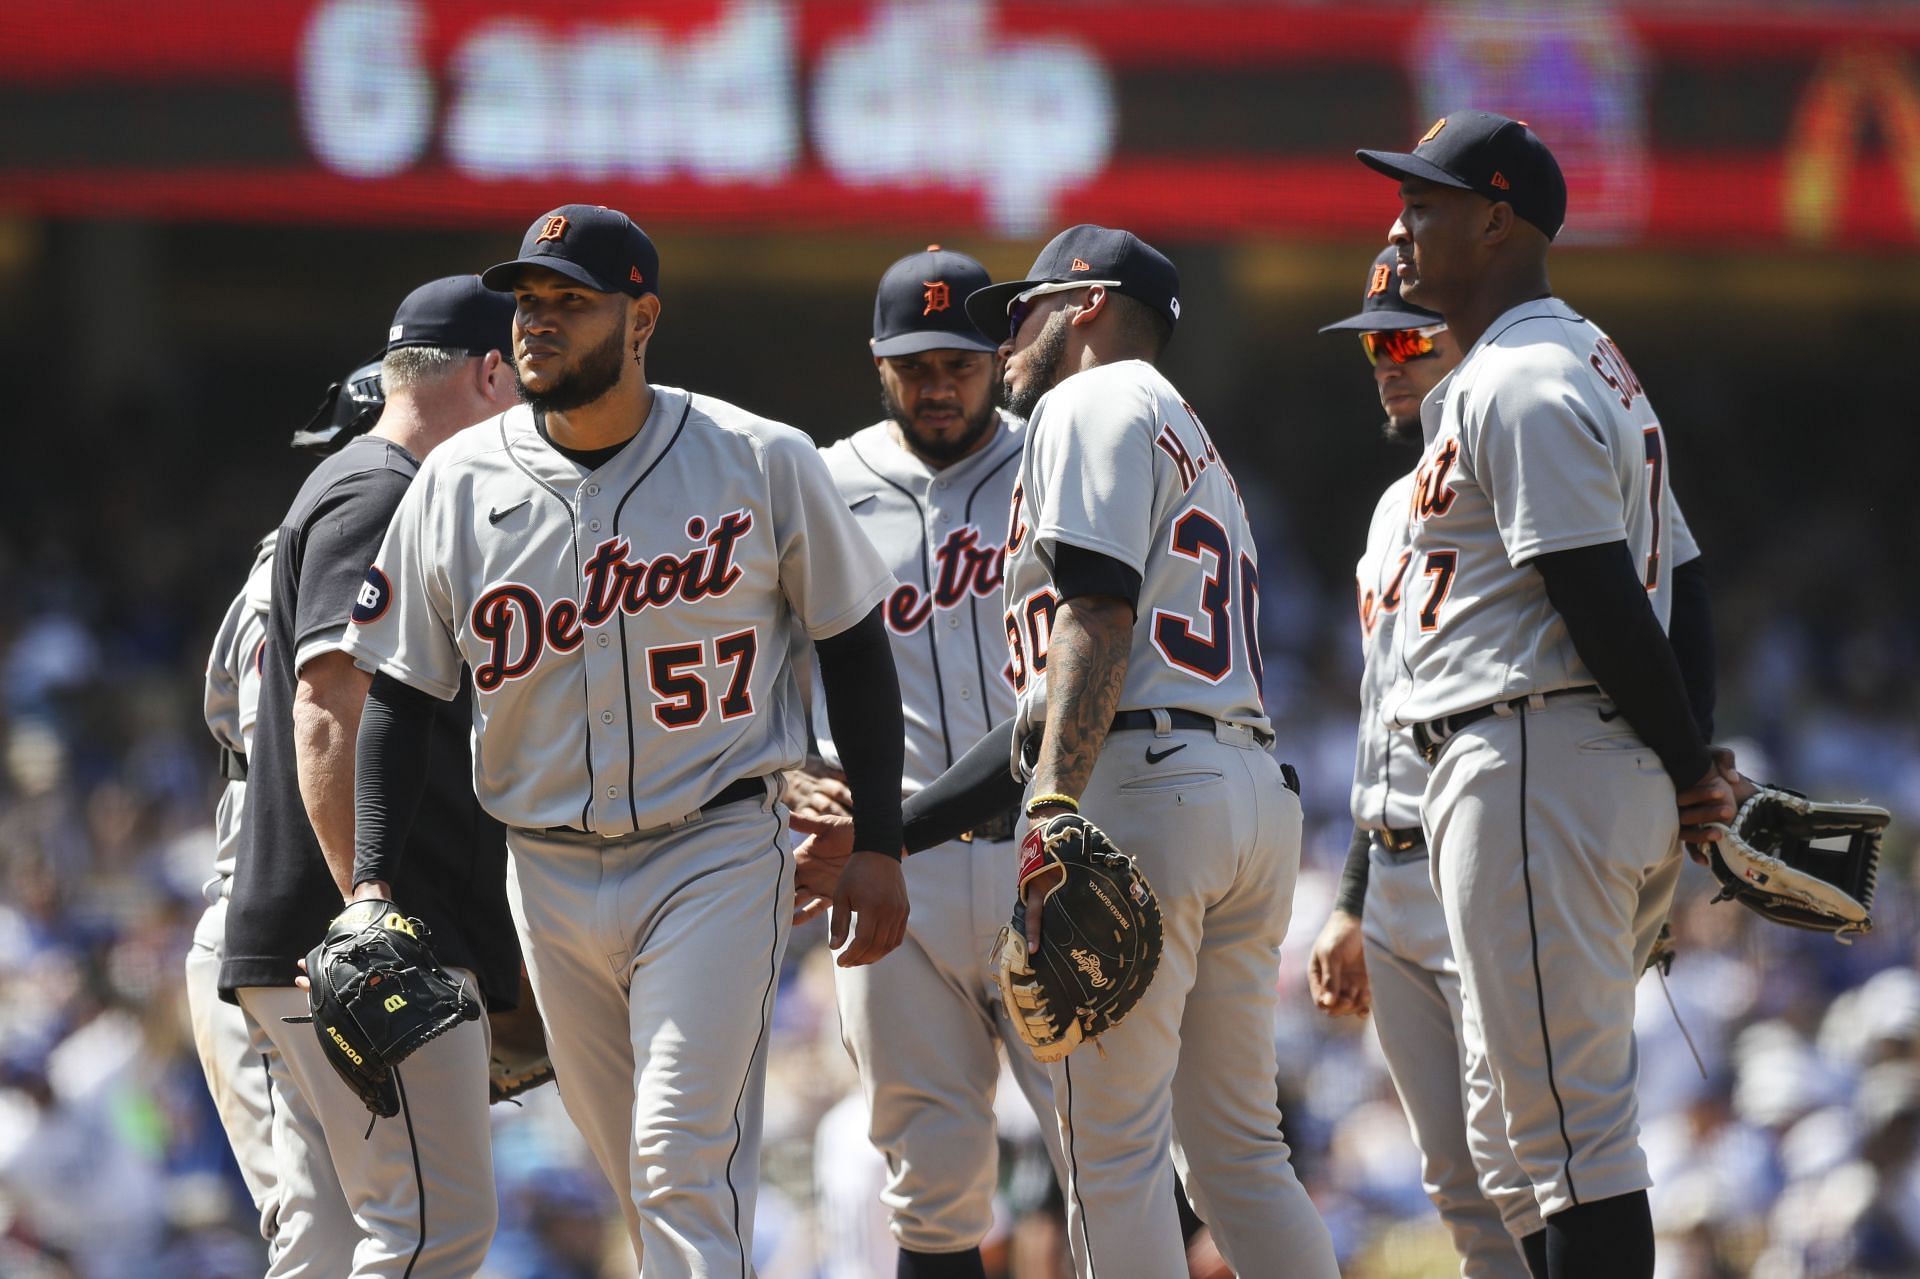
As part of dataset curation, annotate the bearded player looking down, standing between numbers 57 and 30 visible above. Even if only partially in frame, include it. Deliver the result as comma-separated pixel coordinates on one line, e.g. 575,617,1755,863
803,244,1058,1279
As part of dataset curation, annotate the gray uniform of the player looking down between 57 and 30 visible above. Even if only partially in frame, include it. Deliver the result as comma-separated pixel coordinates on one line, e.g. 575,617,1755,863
814,413,1066,1252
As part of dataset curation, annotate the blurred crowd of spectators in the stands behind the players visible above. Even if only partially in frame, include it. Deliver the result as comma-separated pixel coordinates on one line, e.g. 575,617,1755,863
0,460,1920,1279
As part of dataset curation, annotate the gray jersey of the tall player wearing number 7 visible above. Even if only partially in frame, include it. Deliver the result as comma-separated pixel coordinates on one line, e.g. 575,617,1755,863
1386,298,1697,724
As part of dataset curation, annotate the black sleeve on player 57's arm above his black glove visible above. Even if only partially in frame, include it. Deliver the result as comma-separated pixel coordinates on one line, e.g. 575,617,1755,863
353,674,434,883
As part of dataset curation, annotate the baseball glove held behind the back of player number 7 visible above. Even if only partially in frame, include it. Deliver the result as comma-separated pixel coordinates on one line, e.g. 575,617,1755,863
1707,775,1887,941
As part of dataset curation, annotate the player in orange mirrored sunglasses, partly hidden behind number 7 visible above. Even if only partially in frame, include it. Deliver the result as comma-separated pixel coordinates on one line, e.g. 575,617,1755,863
1308,246,1540,1279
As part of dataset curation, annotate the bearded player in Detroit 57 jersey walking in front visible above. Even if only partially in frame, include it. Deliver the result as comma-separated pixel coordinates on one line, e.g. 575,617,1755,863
346,204,906,1279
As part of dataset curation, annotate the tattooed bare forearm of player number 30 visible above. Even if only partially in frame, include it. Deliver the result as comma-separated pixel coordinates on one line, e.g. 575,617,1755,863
1033,595,1133,799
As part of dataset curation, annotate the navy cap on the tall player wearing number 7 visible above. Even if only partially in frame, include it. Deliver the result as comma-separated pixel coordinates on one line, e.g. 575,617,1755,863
1354,111,1567,240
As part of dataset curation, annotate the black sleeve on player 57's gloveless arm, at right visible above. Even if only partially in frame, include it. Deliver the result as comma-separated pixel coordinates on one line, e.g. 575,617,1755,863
814,605,906,857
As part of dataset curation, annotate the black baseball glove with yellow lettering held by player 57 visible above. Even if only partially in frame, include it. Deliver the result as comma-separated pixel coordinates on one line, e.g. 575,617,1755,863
288,899,480,1120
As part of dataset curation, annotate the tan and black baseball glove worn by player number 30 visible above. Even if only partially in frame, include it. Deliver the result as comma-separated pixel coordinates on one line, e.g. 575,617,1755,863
993,812,1162,1062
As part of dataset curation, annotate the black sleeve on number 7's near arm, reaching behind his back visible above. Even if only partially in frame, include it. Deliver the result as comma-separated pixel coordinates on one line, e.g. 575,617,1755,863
1532,542,1713,789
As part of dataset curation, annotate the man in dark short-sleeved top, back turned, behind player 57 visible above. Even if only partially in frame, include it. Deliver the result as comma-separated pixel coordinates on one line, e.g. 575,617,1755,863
219,277,518,1279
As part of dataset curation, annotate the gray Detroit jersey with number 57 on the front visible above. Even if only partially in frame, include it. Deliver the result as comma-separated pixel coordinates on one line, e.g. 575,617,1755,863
346,386,895,825
